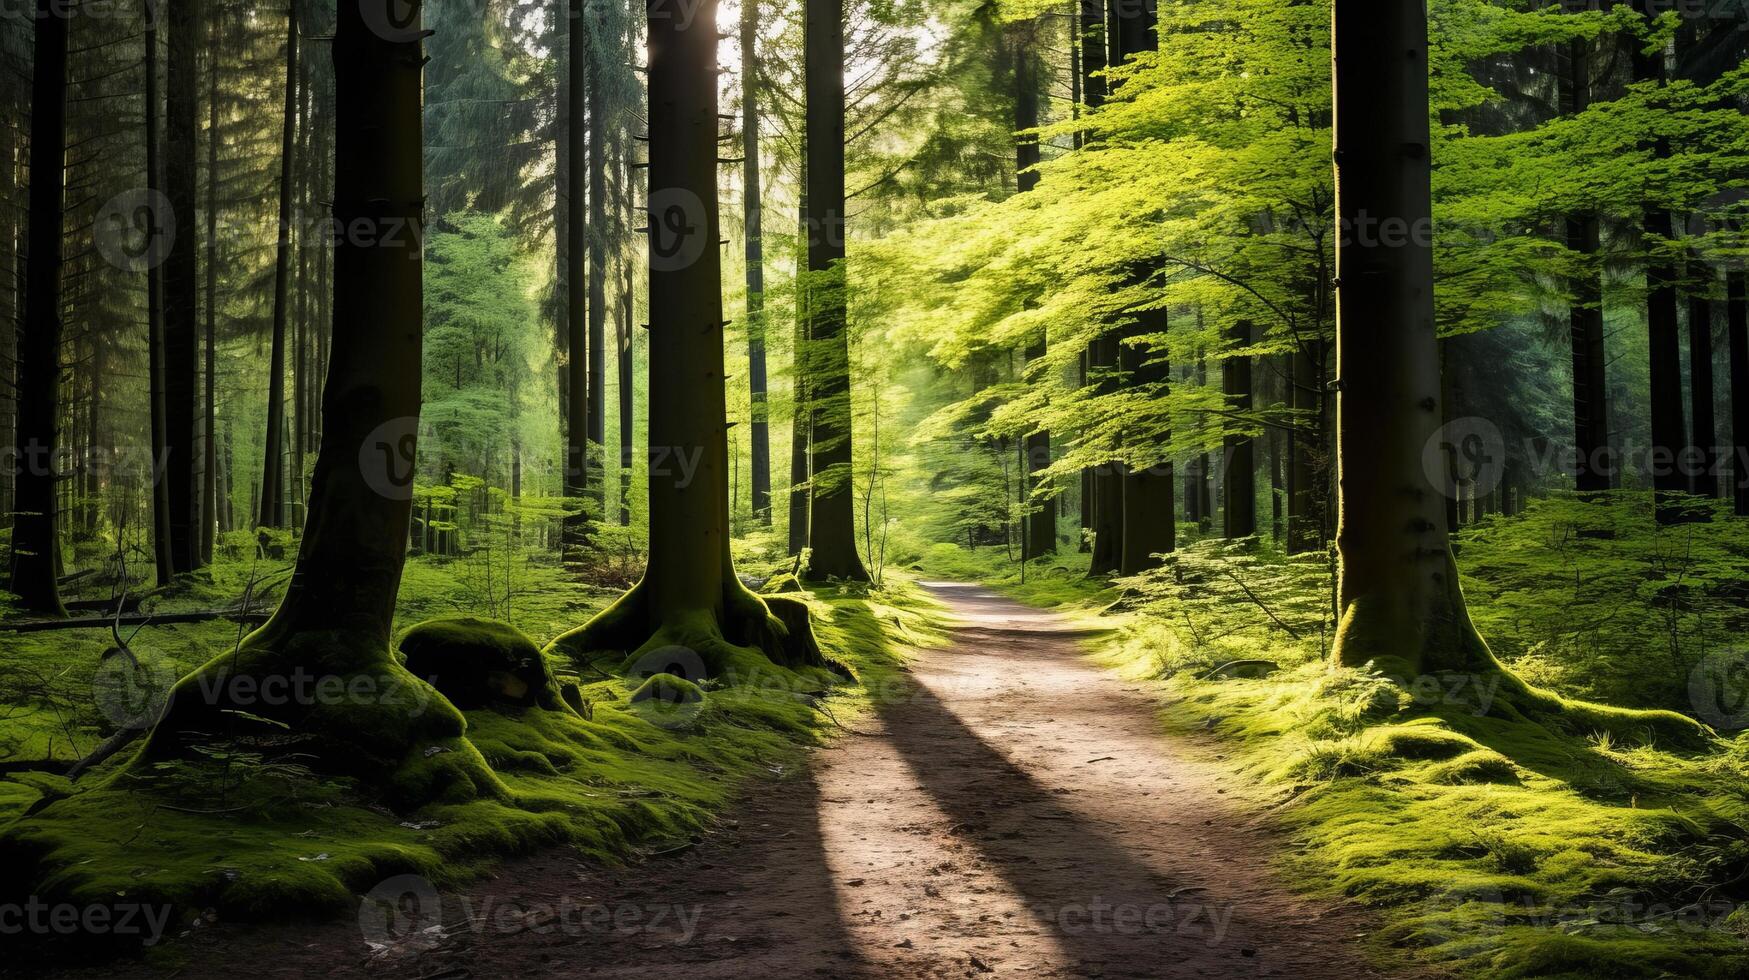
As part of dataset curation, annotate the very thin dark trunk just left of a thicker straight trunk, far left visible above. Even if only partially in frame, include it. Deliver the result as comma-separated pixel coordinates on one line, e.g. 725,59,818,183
145,7,177,586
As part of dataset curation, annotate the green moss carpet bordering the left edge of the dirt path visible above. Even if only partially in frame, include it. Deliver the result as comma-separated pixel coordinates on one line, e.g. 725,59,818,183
0,563,939,952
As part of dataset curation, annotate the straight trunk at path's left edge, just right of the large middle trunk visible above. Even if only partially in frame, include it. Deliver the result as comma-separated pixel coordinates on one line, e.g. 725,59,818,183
803,0,869,581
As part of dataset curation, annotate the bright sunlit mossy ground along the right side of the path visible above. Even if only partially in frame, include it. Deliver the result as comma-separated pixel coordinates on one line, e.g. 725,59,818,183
918,497,1749,978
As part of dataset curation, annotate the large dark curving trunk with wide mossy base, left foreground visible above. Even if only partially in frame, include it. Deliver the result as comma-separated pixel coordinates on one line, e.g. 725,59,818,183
136,0,475,807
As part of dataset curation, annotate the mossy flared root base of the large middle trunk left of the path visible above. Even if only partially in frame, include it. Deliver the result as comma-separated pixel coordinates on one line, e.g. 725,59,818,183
547,578,847,684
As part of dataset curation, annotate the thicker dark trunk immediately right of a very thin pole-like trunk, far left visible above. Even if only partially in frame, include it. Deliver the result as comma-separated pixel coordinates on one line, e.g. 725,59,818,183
164,0,201,574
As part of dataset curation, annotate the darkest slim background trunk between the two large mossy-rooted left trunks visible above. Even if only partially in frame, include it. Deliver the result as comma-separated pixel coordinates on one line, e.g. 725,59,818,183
563,0,591,546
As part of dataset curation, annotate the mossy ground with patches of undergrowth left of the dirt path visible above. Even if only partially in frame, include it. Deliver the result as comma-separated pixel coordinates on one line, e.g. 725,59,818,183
0,542,939,966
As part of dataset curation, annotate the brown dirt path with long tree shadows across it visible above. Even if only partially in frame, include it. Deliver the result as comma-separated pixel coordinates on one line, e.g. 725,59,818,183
41,585,1380,980
